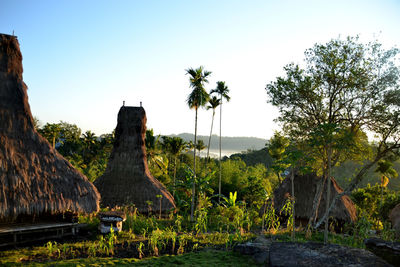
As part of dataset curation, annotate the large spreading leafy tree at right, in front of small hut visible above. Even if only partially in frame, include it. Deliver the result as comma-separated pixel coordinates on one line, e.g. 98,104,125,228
266,37,400,240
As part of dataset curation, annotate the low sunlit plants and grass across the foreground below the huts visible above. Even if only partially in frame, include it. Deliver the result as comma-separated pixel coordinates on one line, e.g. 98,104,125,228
0,194,396,266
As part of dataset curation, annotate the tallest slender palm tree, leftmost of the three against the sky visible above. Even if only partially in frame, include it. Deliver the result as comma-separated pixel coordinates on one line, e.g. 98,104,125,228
186,66,211,221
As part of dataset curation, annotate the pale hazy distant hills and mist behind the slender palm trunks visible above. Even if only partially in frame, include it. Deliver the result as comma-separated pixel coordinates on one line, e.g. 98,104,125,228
170,133,267,156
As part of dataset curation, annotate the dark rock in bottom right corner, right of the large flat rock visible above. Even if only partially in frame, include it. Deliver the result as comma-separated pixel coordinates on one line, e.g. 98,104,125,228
364,238,400,266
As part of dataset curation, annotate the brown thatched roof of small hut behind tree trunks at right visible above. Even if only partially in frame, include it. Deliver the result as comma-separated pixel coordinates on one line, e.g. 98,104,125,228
274,173,357,222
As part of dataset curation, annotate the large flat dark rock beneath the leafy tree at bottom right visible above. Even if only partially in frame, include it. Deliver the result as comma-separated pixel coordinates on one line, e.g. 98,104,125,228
269,242,391,267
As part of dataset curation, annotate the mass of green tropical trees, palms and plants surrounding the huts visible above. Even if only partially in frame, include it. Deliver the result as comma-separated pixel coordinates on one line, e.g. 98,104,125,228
21,37,400,263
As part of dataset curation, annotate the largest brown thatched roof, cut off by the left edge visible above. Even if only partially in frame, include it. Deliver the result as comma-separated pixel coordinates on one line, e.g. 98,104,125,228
0,34,100,221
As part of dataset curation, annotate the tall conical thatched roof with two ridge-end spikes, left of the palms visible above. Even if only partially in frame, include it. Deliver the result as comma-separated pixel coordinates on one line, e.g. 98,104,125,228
94,106,175,213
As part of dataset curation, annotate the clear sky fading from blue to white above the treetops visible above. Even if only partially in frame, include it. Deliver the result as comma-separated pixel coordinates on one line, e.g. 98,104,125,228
0,0,400,138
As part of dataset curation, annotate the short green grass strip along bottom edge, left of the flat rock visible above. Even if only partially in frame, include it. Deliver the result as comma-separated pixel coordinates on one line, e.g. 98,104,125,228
1,249,258,267
